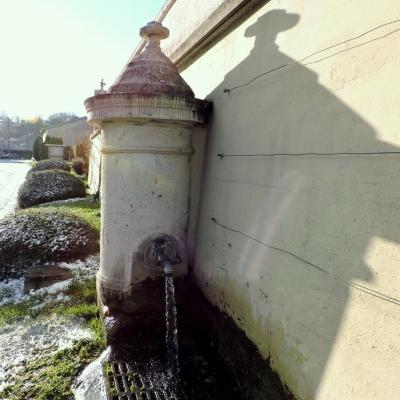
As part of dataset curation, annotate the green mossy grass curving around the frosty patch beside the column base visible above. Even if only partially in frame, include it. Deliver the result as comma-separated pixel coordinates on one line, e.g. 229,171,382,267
0,278,105,400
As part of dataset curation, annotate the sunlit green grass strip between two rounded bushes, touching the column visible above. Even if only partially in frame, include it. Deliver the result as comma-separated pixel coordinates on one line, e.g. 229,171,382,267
36,197,100,233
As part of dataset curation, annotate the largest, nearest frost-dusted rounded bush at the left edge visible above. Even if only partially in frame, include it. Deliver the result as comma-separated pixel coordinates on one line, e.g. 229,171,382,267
0,208,99,280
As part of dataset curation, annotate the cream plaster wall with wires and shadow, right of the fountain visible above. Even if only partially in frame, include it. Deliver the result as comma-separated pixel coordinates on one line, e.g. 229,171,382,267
166,0,400,400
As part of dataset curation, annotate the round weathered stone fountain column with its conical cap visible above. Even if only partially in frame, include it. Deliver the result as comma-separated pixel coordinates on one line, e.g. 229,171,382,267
85,22,208,313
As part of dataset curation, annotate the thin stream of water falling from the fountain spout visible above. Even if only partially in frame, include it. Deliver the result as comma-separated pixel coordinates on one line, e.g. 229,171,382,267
164,262,179,380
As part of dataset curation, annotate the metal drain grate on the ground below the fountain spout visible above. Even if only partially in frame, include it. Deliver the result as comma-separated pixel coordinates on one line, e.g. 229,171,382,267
103,362,186,400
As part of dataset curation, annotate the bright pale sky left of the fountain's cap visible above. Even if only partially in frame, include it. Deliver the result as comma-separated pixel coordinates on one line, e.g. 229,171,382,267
0,0,164,119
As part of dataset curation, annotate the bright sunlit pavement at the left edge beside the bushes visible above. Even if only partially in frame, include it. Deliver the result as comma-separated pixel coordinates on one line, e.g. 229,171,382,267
0,160,30,219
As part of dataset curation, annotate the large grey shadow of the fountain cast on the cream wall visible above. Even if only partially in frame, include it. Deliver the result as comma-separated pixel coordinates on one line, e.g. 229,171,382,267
195,10,400,399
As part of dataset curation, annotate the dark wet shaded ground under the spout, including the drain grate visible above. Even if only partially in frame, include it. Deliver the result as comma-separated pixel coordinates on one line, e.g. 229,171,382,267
93,280,292,400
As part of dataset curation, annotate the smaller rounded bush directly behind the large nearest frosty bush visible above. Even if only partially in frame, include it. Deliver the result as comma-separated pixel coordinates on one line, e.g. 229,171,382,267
18,170,86,208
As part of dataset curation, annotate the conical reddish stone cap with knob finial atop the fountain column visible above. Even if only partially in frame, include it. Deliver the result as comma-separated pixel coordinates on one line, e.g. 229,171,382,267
110,21,194,98
